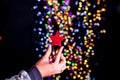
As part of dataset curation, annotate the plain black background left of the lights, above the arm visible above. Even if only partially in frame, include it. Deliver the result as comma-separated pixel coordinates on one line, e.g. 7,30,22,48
0,0,36,80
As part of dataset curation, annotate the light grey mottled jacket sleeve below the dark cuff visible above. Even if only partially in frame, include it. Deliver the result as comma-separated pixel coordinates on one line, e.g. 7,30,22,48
5,70,31,80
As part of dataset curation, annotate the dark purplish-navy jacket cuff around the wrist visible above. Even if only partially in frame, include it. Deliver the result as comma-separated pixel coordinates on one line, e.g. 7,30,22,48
28,66,43,80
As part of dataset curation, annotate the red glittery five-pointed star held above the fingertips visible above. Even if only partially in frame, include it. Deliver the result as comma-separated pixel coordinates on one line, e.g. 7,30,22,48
50,31,64,47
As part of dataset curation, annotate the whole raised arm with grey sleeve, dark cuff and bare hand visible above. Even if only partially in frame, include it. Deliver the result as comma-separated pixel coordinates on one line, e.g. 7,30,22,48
5,45,66,80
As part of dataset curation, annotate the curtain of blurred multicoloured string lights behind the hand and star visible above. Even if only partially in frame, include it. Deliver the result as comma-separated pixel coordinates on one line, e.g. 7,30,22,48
32,0,106,80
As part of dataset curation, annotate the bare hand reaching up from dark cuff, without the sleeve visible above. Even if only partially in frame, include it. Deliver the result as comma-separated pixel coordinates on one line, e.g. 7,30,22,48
35,45,66,77
